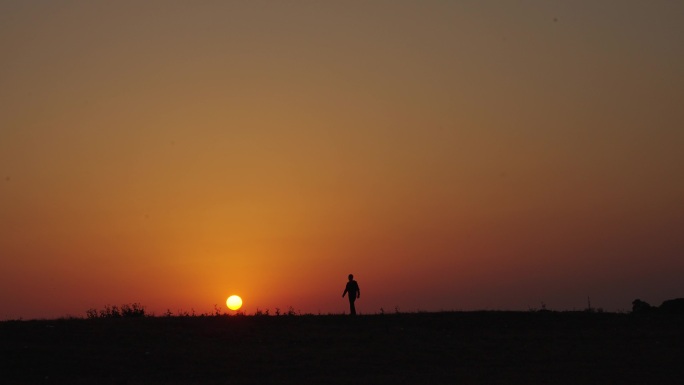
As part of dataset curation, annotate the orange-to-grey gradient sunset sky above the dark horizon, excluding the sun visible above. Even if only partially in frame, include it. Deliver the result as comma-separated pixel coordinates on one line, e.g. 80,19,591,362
0,0,684,319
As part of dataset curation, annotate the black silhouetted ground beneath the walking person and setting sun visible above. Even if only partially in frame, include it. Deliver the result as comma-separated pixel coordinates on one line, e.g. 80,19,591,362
0,312,684,384
